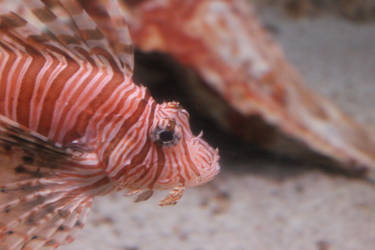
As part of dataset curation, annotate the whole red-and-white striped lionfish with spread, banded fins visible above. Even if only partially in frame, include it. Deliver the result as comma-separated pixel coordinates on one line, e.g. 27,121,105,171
0,0,219,249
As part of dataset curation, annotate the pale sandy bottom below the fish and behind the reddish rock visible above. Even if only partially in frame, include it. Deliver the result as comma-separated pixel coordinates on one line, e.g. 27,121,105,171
62,5,375,250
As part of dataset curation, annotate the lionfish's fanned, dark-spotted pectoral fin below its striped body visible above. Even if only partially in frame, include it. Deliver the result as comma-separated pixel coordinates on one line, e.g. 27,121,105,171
0,116,114,249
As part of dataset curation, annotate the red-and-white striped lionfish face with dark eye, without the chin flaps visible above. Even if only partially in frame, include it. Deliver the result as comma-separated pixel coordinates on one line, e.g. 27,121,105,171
150,102,220,189
